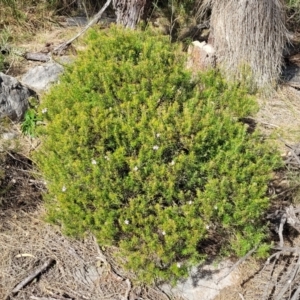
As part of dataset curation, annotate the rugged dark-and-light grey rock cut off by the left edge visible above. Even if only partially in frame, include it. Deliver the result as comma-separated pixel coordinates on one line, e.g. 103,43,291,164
0,72,34,121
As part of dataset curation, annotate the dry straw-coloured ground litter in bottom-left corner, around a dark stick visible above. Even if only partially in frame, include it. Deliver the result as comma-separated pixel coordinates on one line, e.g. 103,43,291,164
0,208,182,300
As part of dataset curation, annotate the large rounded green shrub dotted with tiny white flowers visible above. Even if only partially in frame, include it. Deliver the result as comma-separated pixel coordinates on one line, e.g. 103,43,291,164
35,27,279,282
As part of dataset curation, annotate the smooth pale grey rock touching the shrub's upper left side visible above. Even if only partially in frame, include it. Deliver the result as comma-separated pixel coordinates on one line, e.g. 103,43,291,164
22,62,64,92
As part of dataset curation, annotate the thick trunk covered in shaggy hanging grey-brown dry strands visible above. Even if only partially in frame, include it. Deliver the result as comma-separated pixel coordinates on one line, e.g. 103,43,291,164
198,0,288,91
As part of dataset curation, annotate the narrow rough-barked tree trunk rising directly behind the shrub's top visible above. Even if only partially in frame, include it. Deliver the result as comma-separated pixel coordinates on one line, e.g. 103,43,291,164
113,0,151,29
